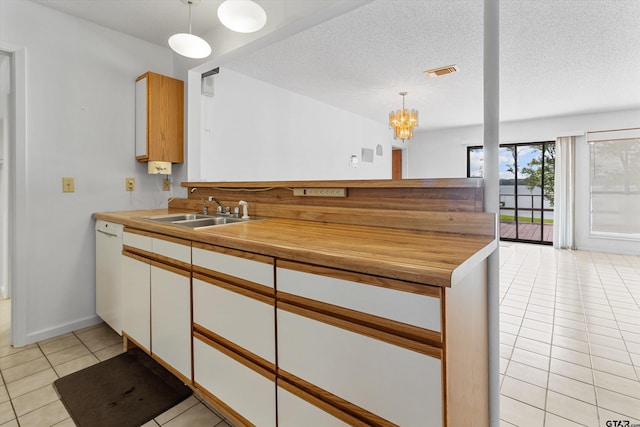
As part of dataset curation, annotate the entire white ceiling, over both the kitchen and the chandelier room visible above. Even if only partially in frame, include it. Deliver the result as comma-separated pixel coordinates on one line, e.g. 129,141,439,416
32,0,640,129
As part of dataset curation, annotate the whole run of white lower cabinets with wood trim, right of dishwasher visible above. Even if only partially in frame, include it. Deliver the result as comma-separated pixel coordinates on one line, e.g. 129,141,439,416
123,230,445,427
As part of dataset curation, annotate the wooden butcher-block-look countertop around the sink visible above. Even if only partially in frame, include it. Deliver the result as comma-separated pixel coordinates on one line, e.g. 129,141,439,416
94,209,497,287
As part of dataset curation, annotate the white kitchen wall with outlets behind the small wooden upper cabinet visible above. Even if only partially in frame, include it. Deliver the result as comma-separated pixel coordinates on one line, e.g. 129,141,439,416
0,0,186,345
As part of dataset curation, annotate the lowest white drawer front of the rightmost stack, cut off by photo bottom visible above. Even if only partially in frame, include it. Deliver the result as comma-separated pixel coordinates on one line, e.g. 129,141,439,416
278,387,349,427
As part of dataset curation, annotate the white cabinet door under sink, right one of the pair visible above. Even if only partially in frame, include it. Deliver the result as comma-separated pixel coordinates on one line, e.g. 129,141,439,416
151,262,191,379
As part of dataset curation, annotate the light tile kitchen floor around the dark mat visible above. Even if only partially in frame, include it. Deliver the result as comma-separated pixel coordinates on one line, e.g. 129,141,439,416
0,299,235,427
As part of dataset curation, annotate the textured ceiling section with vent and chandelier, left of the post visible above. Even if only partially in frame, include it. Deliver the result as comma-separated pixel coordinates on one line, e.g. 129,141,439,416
226,0,483,128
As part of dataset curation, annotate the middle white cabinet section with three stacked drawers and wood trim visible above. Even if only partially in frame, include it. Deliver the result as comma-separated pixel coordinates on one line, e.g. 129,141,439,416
192,243,276,427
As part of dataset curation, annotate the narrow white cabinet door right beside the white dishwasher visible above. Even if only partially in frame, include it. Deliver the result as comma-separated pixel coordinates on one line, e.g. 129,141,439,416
122,254,151,351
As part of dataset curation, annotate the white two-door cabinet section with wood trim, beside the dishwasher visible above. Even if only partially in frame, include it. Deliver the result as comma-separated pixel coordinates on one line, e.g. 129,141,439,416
122,228,191,382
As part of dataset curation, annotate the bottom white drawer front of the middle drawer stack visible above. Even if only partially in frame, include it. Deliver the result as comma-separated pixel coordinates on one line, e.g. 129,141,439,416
193,338,276,427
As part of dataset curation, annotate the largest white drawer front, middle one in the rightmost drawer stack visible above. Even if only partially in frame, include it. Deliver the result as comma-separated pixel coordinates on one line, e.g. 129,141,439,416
277,309,442,426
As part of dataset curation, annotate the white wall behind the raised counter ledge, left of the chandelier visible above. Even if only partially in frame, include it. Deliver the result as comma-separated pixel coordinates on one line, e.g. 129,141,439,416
194,68,393,181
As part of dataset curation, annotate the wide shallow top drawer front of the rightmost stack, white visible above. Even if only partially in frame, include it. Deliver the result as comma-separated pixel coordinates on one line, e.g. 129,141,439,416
276,268,441,332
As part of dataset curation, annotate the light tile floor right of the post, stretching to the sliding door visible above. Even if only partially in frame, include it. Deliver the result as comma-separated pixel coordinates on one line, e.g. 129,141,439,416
500,242,640,427
